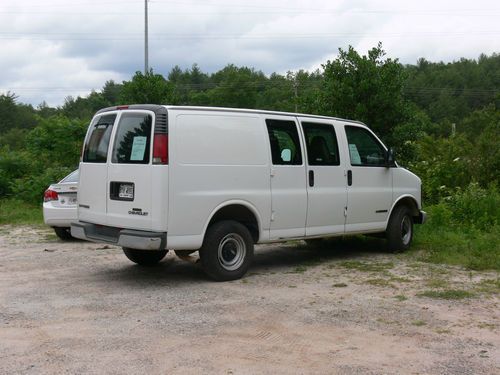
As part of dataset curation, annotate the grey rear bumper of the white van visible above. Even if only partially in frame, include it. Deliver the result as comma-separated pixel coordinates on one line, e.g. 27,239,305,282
71,221,167,250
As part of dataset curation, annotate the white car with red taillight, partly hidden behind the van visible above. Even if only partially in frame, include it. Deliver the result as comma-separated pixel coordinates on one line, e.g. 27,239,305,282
43,169,79,240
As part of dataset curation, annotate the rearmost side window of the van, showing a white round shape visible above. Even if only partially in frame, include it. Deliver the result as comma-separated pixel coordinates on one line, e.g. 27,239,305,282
266,119,302,165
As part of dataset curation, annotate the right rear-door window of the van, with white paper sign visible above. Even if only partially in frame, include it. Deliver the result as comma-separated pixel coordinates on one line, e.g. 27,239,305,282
111,113,153,164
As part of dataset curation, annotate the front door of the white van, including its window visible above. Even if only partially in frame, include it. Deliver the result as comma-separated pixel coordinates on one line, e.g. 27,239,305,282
344,124,392,233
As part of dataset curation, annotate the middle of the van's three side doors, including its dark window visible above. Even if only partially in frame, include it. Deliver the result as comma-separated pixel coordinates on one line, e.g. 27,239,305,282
299,118,347,236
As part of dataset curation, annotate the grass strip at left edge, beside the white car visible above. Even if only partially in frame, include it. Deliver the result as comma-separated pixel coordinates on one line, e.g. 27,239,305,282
0,199,43,225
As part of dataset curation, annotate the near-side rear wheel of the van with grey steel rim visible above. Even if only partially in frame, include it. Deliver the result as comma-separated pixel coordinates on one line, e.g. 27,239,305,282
200,220,253,281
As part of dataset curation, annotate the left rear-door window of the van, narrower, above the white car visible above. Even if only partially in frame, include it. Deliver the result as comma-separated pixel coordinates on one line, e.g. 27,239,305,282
82,114,116,163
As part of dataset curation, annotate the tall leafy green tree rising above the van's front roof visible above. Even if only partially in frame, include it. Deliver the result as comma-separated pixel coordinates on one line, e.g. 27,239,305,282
318,43,407,142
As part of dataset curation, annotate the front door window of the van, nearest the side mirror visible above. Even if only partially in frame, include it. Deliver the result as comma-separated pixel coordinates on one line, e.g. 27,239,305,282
345,126,386,167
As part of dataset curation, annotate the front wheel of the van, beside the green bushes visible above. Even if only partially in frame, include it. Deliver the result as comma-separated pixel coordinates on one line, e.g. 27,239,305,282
386,206,413,252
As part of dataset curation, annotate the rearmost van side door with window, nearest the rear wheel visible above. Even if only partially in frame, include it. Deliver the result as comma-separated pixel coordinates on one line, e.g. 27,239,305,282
265,116,307,239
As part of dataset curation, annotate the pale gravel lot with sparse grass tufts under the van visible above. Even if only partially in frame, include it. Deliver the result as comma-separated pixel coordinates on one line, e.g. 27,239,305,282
0,226,500,374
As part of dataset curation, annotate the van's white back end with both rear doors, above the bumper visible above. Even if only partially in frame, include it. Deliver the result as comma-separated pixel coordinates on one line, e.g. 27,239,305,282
78,105,168,231
